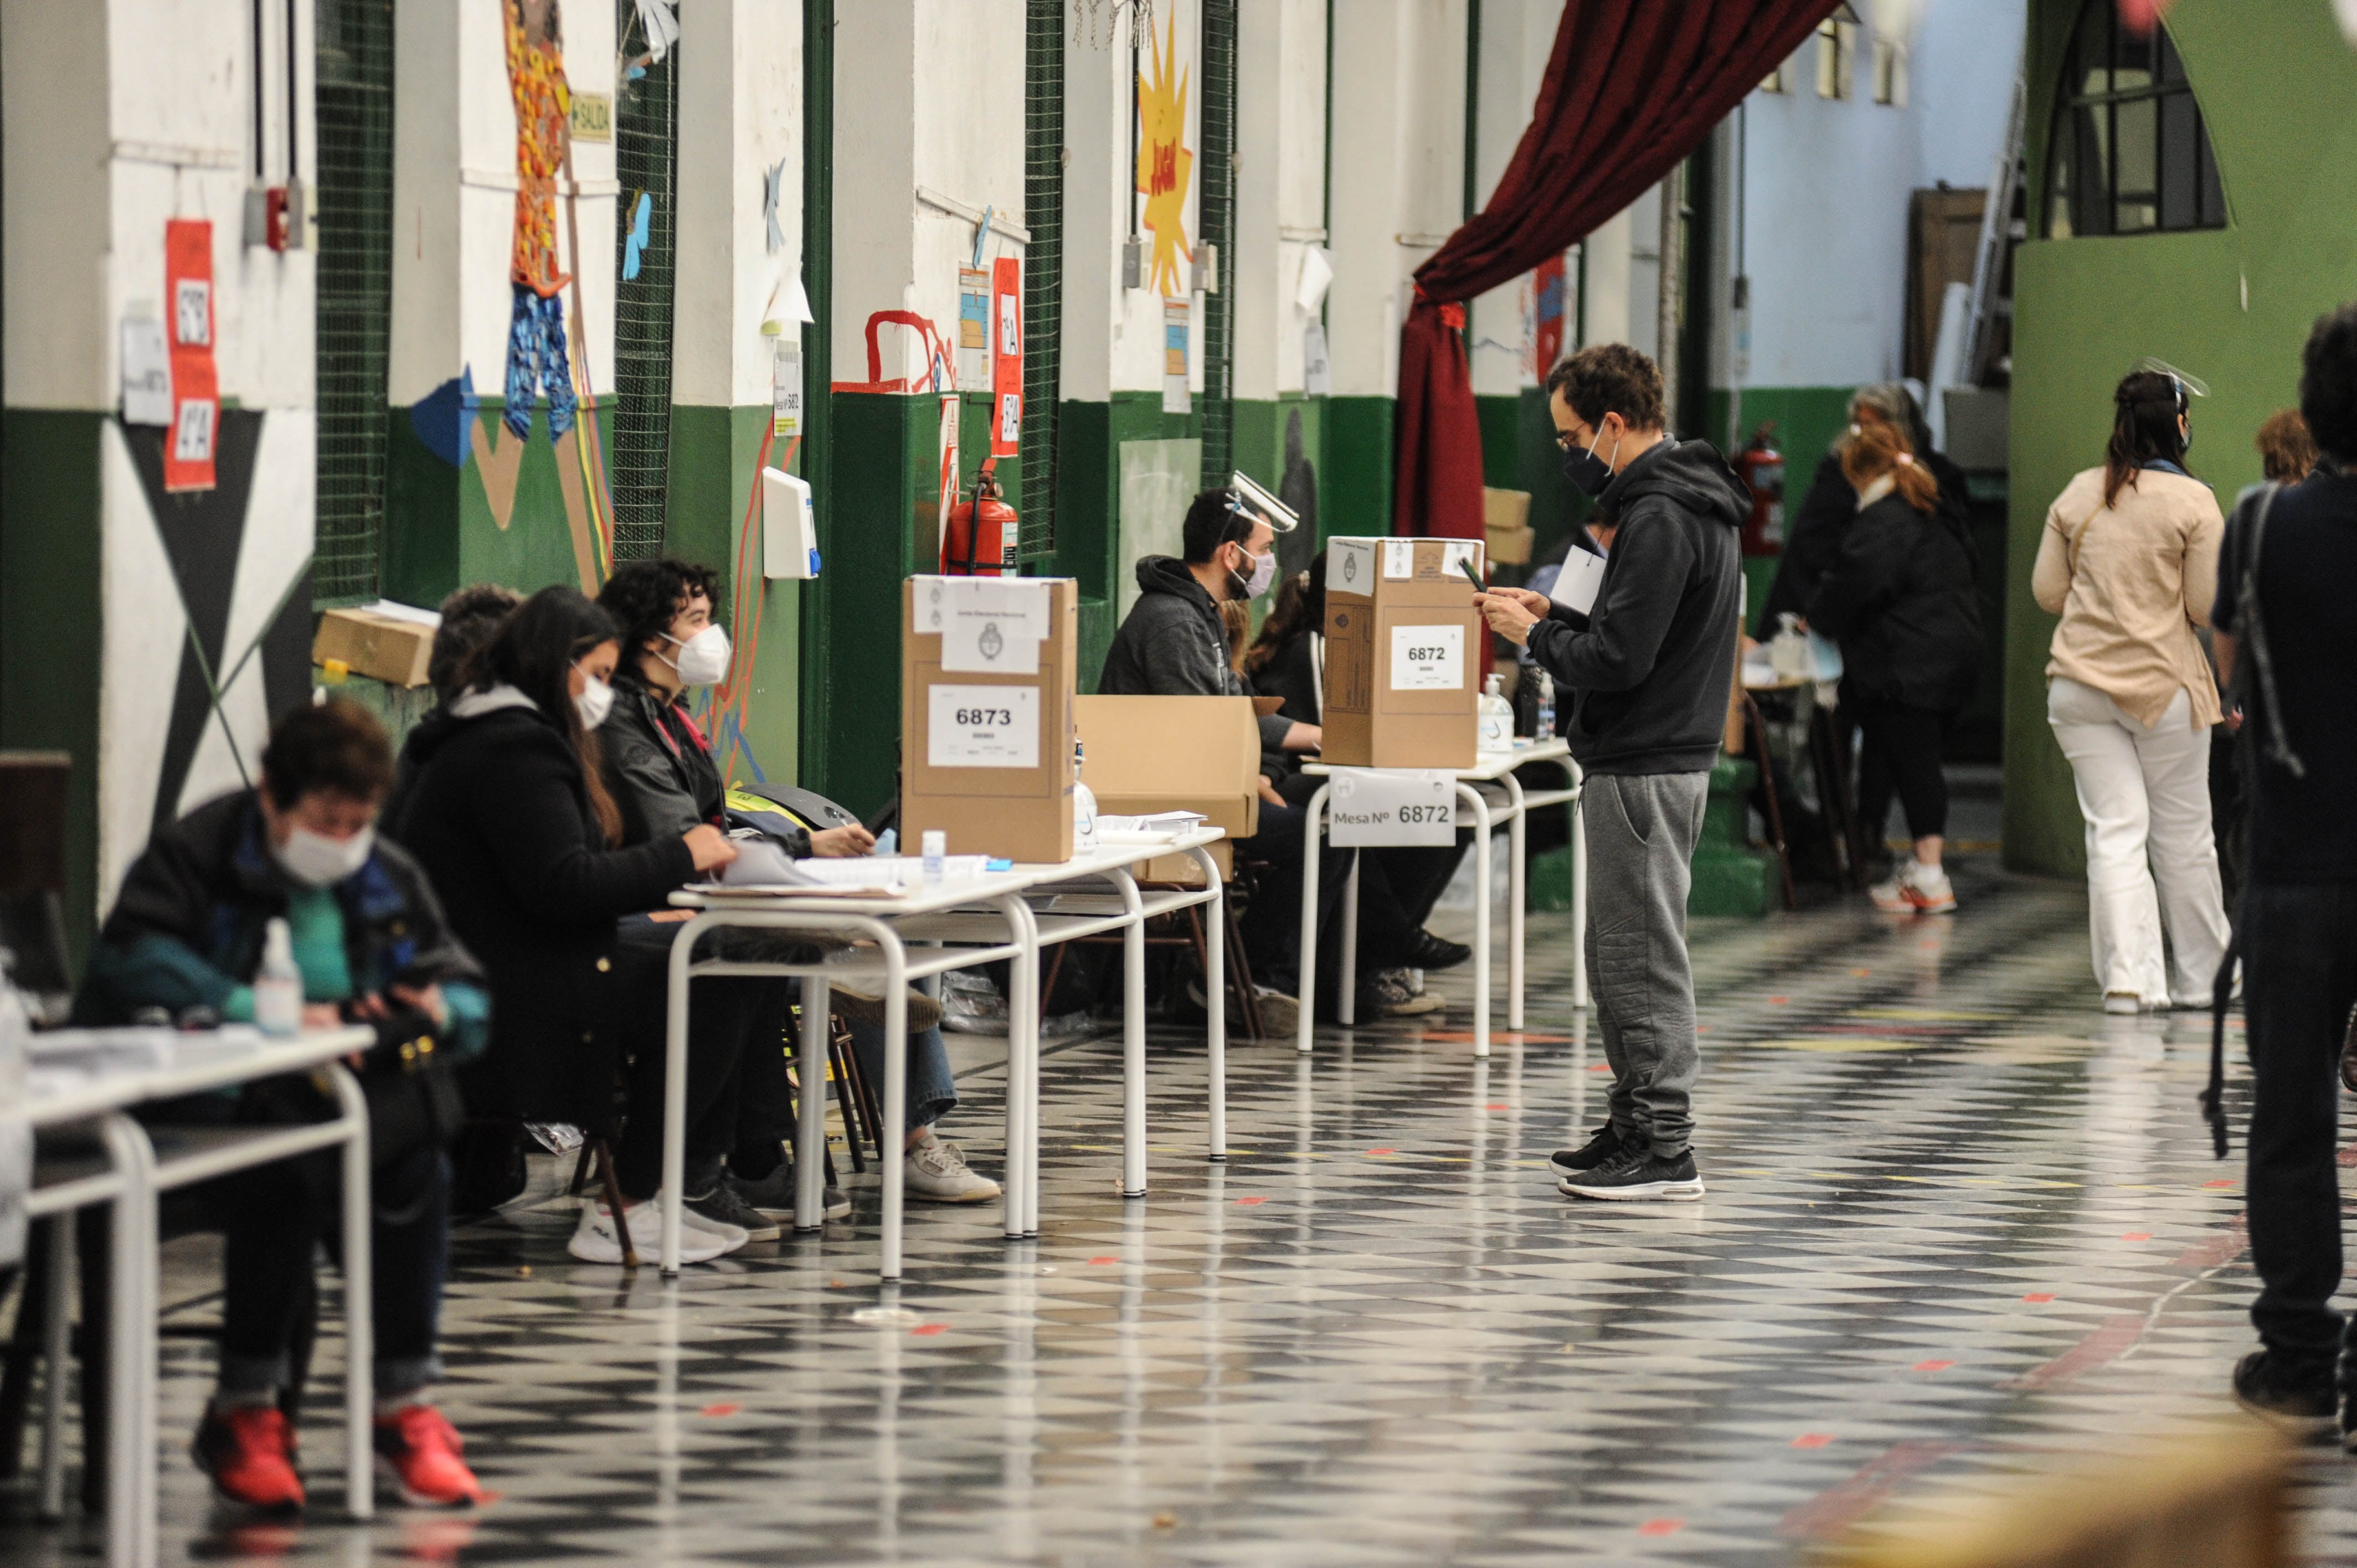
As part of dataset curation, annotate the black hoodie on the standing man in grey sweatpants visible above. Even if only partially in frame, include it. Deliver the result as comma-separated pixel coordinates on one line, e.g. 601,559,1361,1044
1530,436,1751,773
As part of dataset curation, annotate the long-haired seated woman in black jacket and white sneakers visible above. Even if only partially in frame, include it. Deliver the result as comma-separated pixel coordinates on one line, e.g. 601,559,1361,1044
384,587,745,1261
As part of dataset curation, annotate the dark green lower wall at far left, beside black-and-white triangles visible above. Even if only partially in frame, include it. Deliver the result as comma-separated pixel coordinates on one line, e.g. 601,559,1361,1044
0,408,105,969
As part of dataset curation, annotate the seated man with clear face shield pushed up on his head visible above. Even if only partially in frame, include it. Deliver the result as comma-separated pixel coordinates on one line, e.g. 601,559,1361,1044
1096,486,1341,1035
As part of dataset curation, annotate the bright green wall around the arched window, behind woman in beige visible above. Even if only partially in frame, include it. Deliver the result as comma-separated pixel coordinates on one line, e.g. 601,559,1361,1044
2006,0,2357,875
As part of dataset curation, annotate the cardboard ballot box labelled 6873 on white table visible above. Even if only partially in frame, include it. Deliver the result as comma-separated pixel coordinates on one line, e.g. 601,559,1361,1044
900,577,1079,860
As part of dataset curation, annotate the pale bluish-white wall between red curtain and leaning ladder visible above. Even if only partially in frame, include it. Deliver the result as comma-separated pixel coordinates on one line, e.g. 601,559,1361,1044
1744,0,2025,386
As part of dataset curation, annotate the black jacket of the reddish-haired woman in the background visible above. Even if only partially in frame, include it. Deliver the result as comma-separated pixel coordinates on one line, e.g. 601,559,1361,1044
1808,493,1980,712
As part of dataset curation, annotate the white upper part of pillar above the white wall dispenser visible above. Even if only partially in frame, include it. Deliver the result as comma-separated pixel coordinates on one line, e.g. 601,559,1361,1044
672,0,801,408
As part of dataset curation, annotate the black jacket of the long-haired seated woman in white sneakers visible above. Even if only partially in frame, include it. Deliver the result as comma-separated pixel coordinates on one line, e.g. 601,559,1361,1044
384,703,696,1127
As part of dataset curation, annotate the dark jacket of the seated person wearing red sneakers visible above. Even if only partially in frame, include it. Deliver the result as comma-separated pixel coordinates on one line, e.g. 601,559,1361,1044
73,790,483,1026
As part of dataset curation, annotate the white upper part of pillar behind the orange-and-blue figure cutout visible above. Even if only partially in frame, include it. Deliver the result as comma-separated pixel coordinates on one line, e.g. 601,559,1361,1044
389,0,617,408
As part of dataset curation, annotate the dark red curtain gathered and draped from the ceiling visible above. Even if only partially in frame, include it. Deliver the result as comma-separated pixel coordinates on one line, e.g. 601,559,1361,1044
1393,0,1841,538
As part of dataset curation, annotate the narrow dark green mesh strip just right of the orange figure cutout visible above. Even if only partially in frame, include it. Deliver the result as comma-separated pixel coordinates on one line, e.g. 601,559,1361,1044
606,0,679,561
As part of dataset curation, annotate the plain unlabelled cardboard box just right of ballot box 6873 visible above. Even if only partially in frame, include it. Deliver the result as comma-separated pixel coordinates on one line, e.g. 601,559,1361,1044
1072,698,1261,884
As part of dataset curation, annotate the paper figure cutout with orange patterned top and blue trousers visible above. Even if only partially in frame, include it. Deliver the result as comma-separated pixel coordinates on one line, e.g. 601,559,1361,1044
500,0,575,441
